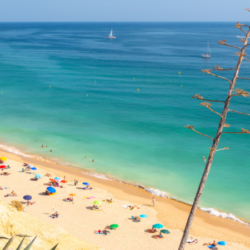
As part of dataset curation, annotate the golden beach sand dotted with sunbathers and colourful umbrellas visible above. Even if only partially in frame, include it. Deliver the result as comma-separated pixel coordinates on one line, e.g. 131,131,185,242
0,148,250,250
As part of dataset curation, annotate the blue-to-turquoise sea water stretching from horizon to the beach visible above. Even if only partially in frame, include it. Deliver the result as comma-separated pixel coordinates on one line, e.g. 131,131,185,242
0,23,250,221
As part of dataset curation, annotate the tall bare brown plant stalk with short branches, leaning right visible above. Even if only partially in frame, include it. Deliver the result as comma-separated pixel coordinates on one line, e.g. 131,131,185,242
178,13,250,250
